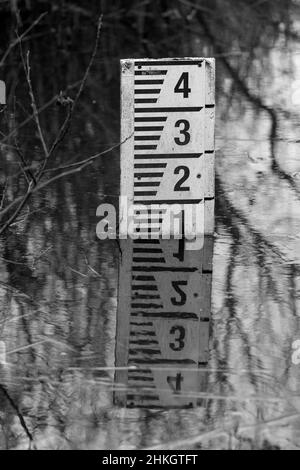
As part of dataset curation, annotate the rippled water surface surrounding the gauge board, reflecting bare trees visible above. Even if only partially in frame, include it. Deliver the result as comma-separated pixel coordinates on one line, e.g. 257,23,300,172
0,0,300,449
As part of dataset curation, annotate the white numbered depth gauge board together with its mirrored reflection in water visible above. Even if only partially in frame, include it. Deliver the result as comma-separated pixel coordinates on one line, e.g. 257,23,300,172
115,58,215,408
